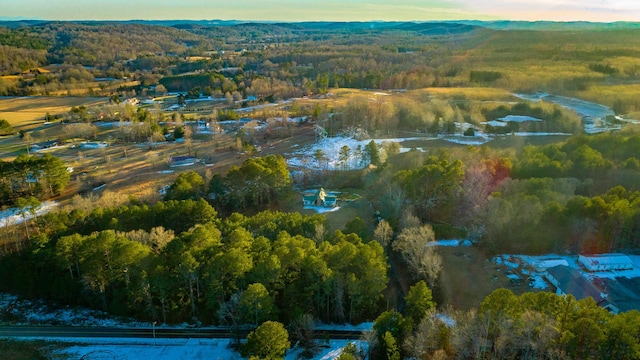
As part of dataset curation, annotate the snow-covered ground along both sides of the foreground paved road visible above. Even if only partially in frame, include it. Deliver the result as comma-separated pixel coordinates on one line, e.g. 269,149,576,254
0,293,373,360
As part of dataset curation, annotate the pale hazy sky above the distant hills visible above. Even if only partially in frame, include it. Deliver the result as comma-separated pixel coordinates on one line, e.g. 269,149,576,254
0,0,640,22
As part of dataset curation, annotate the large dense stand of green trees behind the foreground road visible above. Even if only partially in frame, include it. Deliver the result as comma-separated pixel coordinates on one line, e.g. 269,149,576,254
0,200,387,328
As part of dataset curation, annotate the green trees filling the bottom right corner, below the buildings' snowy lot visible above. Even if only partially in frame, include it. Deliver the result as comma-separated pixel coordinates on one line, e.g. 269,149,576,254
364,289,640,360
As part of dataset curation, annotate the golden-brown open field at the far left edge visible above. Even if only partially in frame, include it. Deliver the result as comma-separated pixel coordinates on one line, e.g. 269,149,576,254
0,96,107,128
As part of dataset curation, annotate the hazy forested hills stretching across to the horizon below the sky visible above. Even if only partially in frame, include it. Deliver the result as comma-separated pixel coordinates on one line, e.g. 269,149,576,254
0,22,640,113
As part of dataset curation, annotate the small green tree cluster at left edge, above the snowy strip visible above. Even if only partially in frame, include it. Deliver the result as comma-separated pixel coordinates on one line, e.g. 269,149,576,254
0,154,71,206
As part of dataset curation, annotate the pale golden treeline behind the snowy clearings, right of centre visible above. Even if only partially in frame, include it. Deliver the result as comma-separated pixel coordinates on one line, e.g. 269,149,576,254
324,95,582,136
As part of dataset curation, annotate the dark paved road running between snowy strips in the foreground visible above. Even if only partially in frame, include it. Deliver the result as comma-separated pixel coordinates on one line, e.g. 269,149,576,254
0,326,361,340
